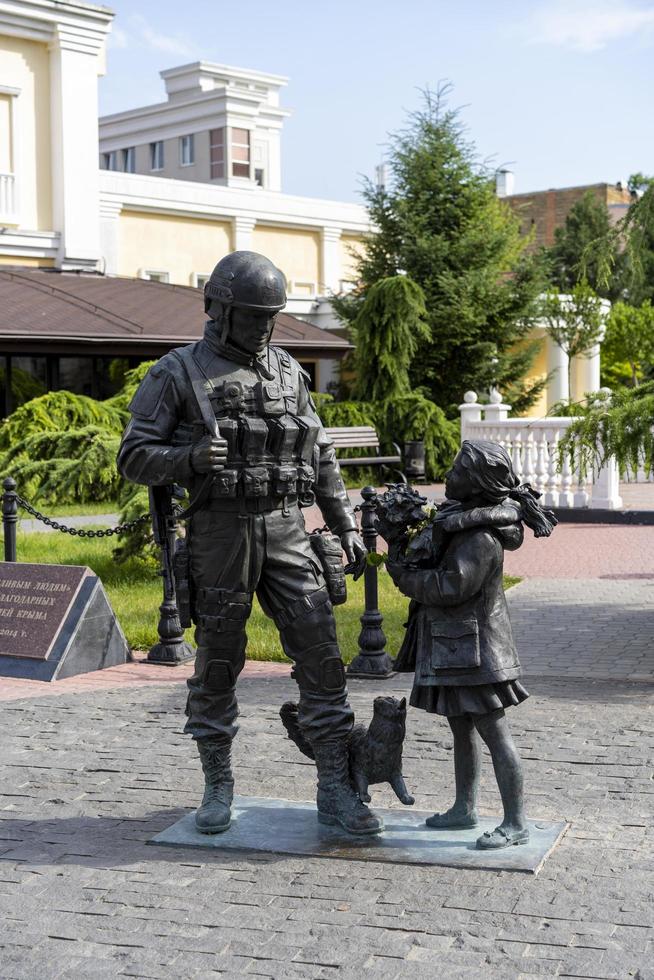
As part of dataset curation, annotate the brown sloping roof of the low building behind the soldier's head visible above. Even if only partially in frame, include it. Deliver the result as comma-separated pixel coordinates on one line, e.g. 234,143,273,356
0,266,352,358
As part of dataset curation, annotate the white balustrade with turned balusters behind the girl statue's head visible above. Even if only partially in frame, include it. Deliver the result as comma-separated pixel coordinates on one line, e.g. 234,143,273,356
459,391,622,510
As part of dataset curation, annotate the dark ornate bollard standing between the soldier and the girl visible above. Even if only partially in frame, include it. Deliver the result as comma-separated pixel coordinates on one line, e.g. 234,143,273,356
347,487,393,679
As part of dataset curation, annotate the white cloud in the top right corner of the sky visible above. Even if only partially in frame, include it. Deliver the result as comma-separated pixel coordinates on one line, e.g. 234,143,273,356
521,0,654,52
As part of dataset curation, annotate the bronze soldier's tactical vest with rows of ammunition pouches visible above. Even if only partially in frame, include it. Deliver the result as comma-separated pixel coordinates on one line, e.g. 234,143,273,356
175,347,320,507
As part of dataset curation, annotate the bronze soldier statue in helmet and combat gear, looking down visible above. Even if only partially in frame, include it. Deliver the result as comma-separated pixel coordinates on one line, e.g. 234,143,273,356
118,251,382,834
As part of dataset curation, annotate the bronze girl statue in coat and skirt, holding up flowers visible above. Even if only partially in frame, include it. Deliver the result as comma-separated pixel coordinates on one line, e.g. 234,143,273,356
380,441,556,848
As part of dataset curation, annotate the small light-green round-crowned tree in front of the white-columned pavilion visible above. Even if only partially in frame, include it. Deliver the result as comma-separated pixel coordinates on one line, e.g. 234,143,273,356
541,283,604,399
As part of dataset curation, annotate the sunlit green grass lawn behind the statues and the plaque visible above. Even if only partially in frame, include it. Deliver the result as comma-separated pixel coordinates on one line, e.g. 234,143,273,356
2,532,520,663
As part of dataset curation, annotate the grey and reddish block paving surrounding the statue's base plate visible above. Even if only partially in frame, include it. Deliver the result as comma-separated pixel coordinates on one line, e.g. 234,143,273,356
0,510,654,980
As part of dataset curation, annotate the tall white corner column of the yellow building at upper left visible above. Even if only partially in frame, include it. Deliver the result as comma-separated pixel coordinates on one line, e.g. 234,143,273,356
50,24,106,269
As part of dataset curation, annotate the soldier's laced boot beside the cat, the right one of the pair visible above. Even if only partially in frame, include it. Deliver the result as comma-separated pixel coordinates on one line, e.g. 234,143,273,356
311,739,384,834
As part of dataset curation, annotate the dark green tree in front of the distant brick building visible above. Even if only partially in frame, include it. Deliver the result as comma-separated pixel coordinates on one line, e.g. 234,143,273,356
546,191,620,299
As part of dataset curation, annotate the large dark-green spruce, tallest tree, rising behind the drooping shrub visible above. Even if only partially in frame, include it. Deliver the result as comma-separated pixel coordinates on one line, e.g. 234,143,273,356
335,86,543,415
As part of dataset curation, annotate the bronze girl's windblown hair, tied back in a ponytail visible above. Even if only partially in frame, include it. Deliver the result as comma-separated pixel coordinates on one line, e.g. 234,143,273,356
458,439,558,538
